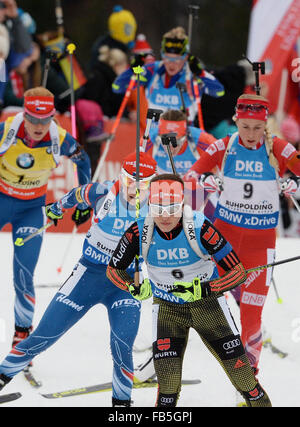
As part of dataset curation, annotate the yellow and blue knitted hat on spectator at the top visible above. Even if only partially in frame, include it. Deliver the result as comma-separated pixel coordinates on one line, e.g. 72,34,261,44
108,6,137,47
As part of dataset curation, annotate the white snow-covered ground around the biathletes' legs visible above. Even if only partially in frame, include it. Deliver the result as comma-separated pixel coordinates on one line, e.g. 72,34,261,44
0,233,300,407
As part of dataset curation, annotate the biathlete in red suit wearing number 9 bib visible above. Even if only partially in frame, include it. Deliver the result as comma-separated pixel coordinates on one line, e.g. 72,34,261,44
184,94,300,373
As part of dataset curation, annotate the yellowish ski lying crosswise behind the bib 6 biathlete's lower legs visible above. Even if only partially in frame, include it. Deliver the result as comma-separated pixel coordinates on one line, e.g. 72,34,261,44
41,379,201,399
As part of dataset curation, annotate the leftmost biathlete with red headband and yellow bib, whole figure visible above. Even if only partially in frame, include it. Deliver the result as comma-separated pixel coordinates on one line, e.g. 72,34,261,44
0,87,91,354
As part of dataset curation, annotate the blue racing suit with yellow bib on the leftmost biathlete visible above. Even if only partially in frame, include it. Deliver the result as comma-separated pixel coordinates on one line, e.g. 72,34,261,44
0,119,91,328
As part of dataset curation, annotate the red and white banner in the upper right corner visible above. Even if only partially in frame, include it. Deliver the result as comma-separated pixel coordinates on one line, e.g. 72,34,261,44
248,0,300,120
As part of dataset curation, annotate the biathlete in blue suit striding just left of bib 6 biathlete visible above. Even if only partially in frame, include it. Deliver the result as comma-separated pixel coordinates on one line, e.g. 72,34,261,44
0,153,156,406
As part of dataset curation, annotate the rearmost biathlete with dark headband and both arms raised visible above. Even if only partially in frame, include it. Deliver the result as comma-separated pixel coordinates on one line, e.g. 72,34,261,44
112,27,224,123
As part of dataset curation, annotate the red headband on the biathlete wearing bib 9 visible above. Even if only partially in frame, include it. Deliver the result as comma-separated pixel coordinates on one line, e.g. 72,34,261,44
235,97,269,122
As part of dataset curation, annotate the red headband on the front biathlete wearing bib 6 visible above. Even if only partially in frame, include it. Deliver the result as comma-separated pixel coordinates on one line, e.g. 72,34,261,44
149,179,184,205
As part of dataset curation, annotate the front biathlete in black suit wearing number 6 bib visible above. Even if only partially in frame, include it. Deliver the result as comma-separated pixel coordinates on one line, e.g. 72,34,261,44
107,174,271,407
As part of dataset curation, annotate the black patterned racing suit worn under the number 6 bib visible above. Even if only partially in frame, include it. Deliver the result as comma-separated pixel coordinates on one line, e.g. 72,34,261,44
107,220,271,406
